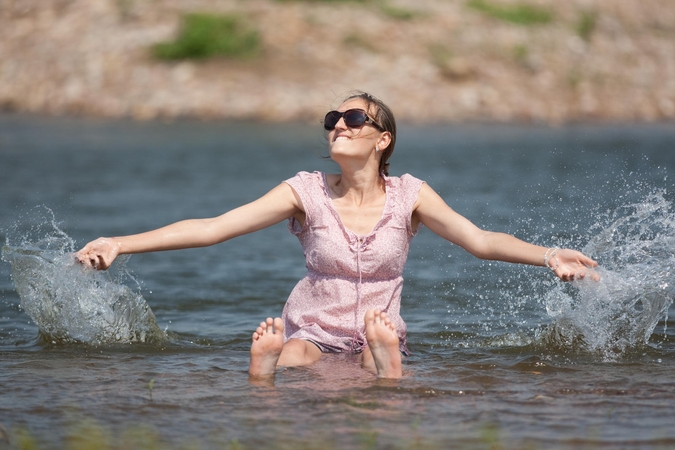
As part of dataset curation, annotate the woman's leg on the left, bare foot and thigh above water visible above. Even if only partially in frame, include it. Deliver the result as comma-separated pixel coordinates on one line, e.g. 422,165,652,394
248,317,321,376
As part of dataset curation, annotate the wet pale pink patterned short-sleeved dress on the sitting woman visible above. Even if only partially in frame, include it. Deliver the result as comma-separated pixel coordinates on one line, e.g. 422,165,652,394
282,172,423,354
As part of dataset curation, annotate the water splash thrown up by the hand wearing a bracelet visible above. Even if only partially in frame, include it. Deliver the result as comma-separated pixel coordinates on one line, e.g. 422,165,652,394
542,191,675,360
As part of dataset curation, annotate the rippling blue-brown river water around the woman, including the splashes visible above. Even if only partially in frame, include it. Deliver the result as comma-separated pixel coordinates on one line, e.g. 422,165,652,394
0,115,675,449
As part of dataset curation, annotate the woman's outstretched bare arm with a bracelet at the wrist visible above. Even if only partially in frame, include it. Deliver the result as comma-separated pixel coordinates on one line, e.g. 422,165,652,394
413,183,599,281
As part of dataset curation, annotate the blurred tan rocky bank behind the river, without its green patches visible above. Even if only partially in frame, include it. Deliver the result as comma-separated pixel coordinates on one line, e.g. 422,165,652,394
0,0,675,123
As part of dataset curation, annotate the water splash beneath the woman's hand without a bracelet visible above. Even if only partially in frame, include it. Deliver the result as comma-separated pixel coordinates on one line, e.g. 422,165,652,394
2,207,166,345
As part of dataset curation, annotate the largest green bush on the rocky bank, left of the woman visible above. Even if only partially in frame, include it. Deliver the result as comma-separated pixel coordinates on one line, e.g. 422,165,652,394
152,14,260,60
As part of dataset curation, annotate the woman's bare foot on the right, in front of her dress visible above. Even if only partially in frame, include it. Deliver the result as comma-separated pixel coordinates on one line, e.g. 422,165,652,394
363,309,403,378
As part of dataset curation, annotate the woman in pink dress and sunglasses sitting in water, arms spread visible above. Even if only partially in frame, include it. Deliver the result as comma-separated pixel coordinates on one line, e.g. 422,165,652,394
78,92,597,378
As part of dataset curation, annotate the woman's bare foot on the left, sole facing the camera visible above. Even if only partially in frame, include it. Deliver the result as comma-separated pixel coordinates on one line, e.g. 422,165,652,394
248,317,284,377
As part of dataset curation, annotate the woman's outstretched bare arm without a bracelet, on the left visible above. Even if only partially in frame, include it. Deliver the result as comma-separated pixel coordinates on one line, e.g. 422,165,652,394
76,183,303,269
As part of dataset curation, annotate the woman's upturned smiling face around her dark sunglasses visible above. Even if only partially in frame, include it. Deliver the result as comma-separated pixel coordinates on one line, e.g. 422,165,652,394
328,98,383,159
